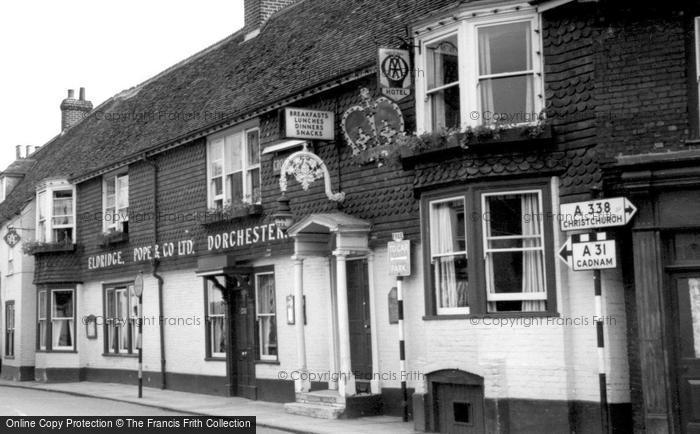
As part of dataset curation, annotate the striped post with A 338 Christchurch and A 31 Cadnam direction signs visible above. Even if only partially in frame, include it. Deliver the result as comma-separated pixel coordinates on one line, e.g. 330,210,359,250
559,195,637,433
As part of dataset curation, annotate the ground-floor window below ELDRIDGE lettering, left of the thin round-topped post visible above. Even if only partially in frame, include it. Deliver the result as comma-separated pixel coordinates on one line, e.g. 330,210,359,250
104,283,139,354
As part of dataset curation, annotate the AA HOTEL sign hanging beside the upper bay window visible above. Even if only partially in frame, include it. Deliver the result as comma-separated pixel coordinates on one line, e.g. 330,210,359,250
377,48,413,101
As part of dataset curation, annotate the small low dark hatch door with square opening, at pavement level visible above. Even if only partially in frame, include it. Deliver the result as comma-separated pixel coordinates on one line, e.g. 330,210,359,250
435,383,485,434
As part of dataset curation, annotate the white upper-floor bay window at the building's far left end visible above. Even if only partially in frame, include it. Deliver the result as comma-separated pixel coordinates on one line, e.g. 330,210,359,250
36,181,75,244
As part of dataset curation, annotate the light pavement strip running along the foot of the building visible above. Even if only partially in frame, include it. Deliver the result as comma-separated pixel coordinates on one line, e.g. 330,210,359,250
0,380,415,434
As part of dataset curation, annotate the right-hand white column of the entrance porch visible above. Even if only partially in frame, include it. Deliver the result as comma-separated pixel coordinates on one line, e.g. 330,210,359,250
333,250,357,396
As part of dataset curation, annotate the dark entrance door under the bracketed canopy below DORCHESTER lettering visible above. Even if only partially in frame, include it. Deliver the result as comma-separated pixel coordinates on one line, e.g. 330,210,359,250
233,288,257,399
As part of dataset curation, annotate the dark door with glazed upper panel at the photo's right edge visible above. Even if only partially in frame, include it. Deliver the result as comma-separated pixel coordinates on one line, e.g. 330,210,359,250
673,272,700,434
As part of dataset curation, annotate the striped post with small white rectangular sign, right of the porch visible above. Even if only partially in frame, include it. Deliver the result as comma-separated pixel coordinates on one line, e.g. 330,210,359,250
387,232,411,422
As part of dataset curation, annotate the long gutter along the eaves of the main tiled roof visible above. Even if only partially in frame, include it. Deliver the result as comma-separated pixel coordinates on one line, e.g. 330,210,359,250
70,62,377,184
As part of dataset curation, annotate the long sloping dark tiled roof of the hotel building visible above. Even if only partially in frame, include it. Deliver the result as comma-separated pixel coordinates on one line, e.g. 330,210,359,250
0,0,456,220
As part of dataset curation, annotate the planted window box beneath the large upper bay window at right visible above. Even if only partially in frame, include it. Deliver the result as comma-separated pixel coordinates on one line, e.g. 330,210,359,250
400,124,552,169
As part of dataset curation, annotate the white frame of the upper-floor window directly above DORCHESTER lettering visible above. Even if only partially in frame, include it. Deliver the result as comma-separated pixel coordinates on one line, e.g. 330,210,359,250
207,126,262,208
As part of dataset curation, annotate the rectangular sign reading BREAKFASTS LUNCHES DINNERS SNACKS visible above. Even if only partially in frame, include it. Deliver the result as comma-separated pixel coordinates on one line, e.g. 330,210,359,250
281,107,335,140
